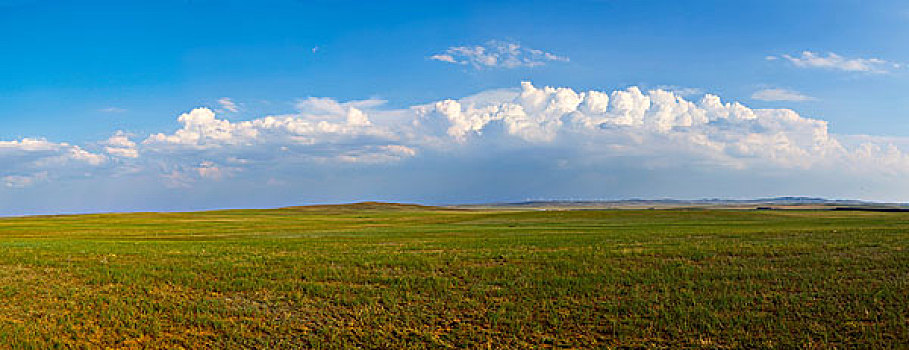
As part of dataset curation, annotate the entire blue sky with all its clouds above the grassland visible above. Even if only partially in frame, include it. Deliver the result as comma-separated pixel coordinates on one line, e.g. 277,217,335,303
0,0,909,215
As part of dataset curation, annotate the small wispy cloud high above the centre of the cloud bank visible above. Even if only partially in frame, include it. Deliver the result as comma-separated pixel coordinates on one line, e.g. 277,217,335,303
429,40,569,69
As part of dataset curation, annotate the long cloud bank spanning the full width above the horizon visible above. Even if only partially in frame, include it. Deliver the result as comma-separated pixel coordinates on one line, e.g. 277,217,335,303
0,82,909,213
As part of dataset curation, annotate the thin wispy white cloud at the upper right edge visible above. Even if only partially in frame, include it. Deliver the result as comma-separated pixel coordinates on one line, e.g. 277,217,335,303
766,51,901,73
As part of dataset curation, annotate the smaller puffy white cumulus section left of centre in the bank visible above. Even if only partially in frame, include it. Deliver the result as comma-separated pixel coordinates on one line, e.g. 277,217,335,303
139,98,417,186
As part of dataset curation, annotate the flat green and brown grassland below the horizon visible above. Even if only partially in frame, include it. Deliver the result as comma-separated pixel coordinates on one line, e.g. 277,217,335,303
0,204,909,349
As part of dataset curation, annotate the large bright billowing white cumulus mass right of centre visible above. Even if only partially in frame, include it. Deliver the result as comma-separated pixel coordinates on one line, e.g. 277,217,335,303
417,83,909,172
